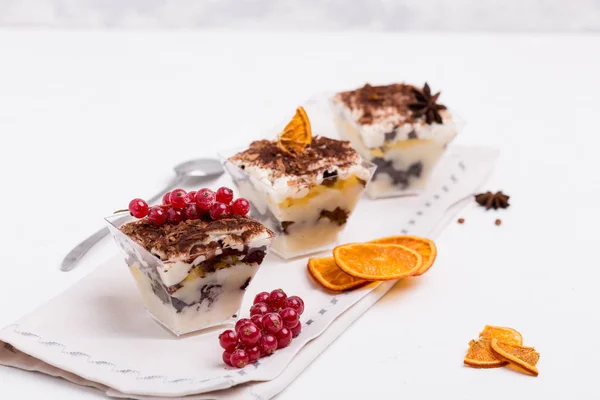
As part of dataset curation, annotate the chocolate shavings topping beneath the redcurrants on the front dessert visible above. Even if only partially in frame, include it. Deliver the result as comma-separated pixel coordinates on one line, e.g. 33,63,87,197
121,215,274,263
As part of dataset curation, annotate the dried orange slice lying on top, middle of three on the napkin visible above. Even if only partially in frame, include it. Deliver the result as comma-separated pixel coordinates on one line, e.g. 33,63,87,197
333,243,423,281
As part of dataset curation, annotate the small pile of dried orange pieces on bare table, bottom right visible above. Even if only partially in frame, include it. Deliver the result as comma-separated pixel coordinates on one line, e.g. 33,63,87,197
464,325,540,376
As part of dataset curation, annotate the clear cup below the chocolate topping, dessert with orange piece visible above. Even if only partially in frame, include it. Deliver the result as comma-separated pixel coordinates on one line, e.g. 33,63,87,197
222,152,375,259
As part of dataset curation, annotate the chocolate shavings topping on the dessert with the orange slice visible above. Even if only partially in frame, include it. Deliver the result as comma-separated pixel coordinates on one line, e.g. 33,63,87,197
230,136,360,178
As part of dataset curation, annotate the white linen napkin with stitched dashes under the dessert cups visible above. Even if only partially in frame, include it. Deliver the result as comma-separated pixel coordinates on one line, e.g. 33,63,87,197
0,147,497,399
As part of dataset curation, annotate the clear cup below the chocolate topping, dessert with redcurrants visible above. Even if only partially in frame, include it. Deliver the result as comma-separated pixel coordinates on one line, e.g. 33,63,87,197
106,214,274,336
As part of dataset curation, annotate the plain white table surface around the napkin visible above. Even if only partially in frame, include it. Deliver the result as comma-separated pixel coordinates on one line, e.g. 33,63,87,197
0,30,600,400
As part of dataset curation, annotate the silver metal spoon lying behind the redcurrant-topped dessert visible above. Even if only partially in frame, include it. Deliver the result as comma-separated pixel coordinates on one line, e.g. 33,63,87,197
60,158,224,271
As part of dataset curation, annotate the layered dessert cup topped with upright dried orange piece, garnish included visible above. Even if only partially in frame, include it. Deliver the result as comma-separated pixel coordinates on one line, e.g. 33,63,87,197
225,107,375,259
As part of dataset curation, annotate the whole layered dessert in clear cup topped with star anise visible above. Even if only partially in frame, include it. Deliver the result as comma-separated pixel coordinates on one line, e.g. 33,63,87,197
332,83,457,198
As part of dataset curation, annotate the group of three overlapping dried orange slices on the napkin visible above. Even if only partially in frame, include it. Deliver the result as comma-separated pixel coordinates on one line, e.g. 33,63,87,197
308,236,437,291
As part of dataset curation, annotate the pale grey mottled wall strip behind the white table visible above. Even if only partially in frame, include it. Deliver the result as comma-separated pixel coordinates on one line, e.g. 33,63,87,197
0,0,600,32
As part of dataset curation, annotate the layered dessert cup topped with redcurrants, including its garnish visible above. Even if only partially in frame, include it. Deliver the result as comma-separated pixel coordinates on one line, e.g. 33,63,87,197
106,188,275,335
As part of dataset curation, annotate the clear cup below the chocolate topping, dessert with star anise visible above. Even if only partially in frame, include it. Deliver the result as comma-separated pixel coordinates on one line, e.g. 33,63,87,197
331,90,464,198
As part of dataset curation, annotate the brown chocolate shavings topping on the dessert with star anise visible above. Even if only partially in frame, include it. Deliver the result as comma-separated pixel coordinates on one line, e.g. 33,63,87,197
338,83,419,125
